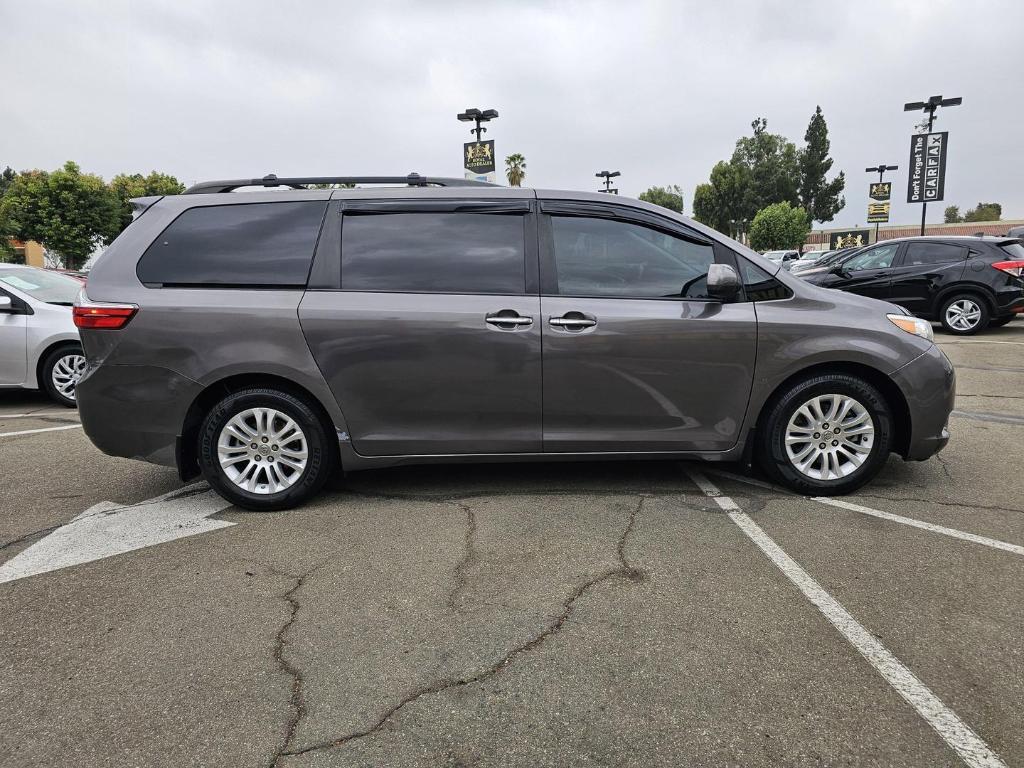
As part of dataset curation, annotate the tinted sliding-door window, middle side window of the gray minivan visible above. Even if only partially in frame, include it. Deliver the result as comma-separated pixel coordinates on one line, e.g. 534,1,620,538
341,213,526,294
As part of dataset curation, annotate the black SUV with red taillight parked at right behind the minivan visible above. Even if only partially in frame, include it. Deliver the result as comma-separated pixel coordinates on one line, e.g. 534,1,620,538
799,237,1024,335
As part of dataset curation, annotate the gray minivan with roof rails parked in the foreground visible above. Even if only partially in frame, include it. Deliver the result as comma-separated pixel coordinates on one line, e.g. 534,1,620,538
74,174,954,509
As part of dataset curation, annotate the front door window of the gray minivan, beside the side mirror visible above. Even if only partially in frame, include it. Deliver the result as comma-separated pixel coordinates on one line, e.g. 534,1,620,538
551,216,715,299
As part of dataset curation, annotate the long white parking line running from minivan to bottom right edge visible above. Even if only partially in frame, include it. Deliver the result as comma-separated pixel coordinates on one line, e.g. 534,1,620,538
688,470,1007,768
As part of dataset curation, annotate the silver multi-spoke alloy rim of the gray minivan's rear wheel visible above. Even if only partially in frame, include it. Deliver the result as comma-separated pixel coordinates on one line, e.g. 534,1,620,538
217,408,309,496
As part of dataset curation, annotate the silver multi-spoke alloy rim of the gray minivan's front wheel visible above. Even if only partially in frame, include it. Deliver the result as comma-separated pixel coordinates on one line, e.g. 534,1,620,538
785,394,874,480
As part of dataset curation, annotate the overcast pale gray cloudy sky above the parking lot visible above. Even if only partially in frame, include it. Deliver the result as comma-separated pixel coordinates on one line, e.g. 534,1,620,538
0,0,1024,225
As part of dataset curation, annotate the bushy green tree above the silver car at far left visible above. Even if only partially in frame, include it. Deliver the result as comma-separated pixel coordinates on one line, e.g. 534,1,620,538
0,161,122,269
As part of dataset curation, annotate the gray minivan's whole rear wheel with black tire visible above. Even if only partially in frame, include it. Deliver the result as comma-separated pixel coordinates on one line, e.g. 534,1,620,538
198,388,335,512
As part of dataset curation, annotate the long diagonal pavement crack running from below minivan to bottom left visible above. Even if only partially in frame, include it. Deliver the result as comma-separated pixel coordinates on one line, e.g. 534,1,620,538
275,496,646,764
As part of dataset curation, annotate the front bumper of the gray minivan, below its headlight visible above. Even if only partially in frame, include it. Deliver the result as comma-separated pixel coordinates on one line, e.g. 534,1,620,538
892,346,956,462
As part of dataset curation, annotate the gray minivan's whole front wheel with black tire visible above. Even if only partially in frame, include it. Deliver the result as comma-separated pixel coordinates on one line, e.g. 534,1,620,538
759,374,893,496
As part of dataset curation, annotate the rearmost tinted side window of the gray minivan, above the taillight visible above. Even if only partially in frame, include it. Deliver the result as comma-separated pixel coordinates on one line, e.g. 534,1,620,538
137,202,327,286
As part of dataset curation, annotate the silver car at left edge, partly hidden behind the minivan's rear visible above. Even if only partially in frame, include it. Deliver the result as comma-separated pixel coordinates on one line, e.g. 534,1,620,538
0,264,85,408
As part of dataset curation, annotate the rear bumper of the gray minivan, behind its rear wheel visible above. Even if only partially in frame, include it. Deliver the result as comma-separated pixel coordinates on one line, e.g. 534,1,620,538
76,365,203,467
